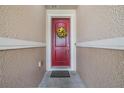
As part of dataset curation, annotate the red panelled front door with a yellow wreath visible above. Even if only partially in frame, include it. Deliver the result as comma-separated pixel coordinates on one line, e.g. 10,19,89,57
52,18,70,66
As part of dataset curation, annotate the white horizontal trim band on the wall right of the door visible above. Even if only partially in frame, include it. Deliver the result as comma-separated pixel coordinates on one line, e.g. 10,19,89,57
76,37,124,50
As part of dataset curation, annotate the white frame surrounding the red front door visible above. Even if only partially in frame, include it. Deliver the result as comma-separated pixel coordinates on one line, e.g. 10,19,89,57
46,10,76,71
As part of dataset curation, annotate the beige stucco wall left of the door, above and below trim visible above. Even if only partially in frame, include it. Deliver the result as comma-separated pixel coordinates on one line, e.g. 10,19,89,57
0,6,45,87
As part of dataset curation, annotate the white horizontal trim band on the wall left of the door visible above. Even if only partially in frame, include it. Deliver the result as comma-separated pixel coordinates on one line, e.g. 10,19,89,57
0,37,46,50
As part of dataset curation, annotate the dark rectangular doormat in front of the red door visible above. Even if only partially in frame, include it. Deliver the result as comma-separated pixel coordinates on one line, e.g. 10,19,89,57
50,71,70,78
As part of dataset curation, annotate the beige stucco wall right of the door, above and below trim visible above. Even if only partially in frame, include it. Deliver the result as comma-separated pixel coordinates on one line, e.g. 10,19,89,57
77,6,124,87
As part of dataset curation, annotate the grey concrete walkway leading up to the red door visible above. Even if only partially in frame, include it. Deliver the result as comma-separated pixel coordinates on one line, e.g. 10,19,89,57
39,72,85,88
